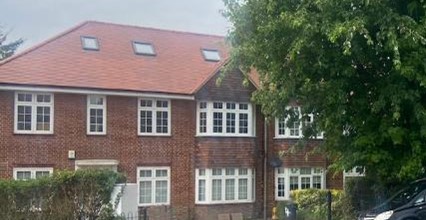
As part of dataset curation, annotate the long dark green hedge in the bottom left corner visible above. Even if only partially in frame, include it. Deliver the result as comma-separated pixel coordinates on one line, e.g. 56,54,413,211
0,170,125,220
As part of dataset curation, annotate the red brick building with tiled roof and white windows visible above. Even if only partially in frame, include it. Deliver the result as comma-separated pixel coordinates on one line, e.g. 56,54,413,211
0,22,343,219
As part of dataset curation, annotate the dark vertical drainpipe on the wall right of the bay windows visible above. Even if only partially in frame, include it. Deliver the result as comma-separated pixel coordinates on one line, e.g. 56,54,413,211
263,117,268,220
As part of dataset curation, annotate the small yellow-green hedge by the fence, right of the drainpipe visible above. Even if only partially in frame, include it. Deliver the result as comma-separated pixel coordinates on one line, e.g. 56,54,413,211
277,189,356,220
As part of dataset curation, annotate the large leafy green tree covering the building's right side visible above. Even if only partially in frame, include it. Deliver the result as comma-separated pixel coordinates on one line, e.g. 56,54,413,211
224,0,426,181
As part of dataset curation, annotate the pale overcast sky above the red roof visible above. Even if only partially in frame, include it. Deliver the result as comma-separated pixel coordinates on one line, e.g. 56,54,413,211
0,0,230,50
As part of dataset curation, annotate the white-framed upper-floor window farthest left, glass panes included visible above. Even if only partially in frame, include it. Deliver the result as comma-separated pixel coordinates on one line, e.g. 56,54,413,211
14,92,53,134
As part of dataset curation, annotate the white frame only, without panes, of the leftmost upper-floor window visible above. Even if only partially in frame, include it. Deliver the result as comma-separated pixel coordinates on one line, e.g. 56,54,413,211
14,91,55,134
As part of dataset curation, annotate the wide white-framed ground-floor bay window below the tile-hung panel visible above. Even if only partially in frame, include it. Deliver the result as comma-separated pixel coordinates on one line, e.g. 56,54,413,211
195,168,255,204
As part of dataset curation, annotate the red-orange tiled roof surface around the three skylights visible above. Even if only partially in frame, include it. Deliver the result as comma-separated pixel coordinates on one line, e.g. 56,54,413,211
0,21,228,94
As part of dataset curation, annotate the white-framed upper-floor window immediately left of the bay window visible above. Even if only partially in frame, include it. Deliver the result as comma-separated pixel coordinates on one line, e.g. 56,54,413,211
138,98,171,135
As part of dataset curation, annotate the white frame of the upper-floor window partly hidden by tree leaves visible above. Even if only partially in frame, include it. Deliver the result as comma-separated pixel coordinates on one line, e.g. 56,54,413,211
275,107,324,139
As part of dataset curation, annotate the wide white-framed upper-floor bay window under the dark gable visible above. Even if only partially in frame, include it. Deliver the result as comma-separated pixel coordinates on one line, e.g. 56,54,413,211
197,101,255,136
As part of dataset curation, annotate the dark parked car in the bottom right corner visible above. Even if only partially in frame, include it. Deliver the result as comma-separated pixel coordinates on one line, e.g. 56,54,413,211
358,178,426,220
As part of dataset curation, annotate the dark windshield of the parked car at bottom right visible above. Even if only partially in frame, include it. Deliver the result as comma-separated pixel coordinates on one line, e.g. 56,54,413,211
386,181,426,210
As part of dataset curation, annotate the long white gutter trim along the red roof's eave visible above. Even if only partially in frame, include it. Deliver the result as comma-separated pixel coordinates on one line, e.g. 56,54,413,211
0,85,195,100
